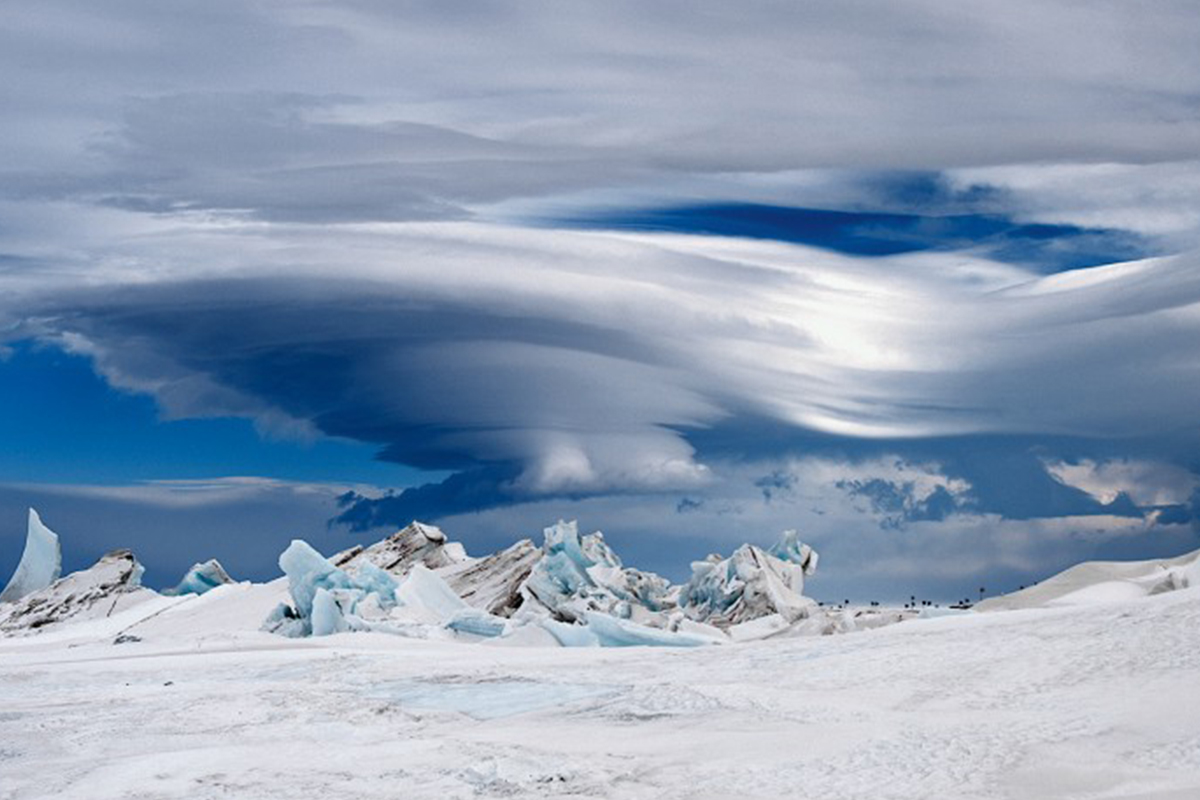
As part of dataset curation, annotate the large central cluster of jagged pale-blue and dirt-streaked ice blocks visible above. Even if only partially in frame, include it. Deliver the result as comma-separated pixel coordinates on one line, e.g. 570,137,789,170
263,521,853,646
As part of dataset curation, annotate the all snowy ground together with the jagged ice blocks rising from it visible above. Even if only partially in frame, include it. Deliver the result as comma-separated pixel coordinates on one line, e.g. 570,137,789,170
7,515,1200,800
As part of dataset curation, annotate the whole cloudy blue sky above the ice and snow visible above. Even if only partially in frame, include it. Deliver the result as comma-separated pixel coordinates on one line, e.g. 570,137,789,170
0,0,1200,601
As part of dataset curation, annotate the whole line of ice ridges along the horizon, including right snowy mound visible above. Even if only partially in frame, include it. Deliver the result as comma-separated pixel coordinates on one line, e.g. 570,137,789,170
11,513,1200,648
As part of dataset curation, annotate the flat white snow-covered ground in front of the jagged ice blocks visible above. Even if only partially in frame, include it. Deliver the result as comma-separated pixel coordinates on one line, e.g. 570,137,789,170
0,582,1200,800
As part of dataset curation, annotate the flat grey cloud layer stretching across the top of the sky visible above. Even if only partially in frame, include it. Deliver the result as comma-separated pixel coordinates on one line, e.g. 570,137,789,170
0,0,1200,227
